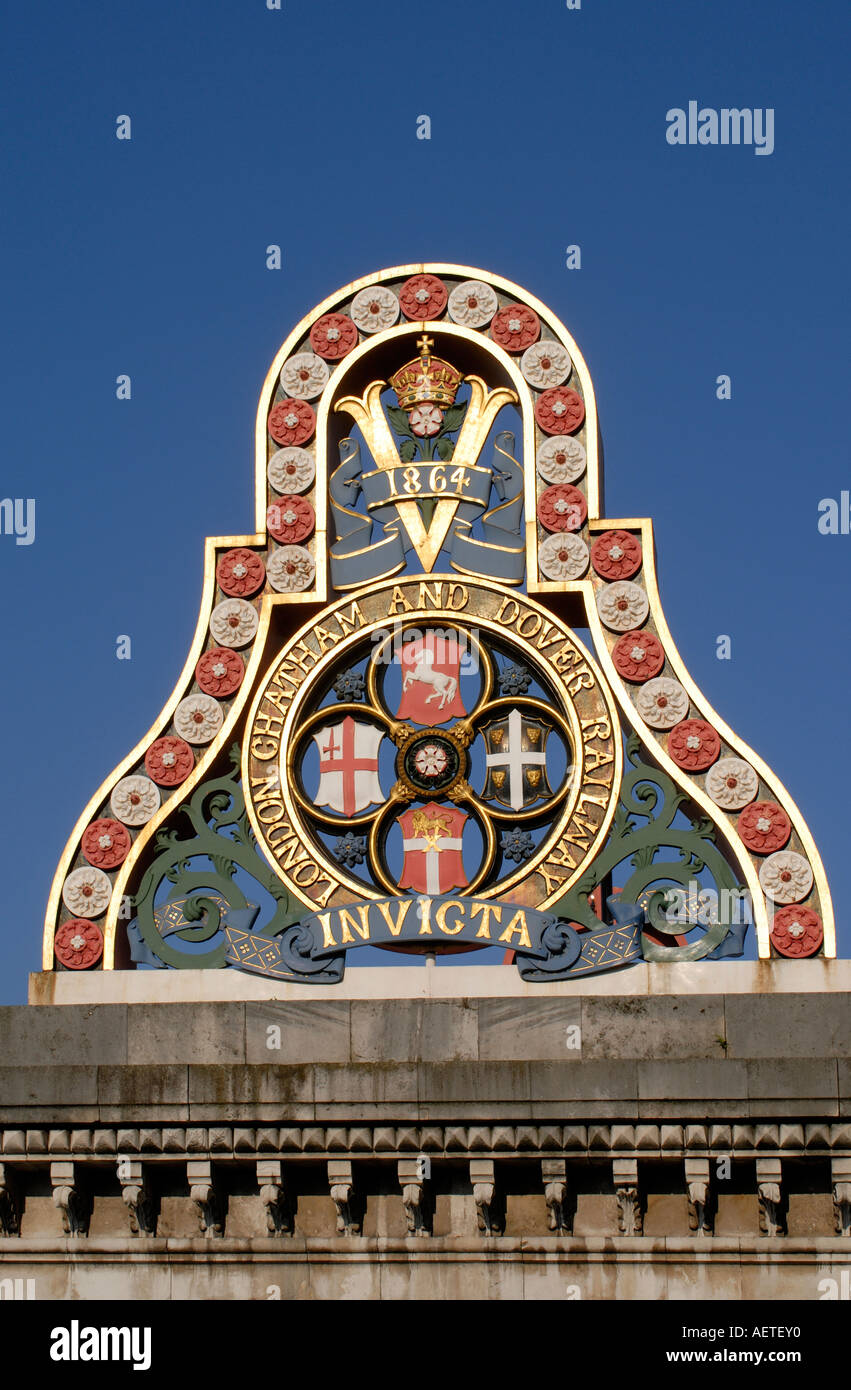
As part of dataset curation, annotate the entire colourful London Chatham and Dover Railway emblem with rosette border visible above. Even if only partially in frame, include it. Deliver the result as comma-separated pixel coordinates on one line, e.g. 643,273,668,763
44,265,836,984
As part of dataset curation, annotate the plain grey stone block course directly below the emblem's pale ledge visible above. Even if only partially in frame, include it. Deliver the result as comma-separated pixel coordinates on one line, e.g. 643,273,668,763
9,989,851,1061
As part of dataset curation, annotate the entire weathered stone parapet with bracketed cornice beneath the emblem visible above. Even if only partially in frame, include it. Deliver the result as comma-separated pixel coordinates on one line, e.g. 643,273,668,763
0,989,851,1298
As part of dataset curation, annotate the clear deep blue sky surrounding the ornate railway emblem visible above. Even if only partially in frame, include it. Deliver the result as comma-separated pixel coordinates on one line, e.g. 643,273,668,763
0,0,851,1002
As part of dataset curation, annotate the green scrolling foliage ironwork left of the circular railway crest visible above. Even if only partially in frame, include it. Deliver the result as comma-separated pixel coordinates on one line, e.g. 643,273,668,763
135,745,299,970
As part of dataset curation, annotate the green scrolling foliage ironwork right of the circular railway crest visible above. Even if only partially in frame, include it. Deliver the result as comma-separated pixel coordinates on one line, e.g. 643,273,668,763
552,734,744,960
